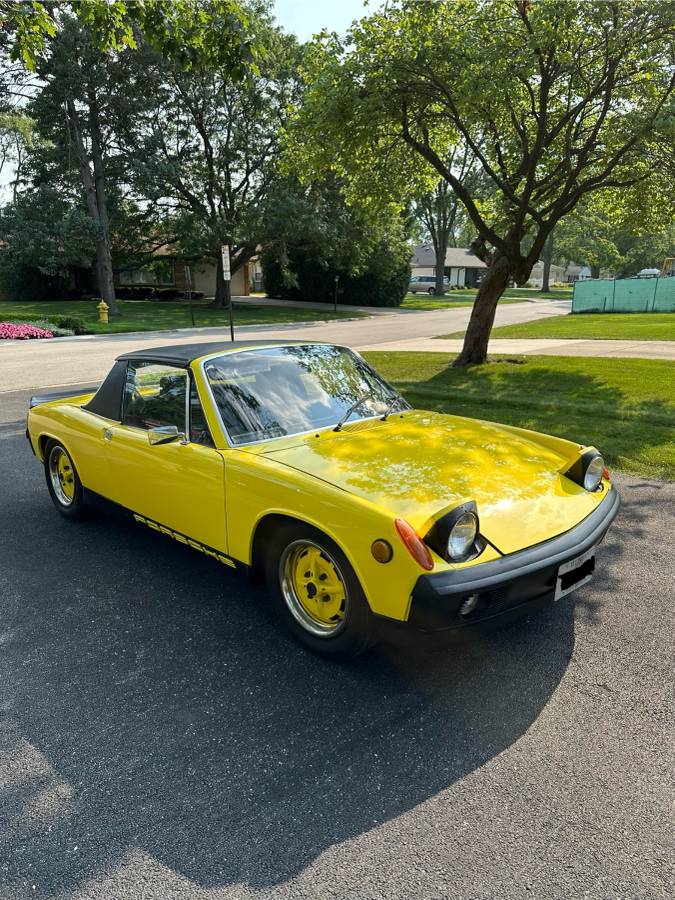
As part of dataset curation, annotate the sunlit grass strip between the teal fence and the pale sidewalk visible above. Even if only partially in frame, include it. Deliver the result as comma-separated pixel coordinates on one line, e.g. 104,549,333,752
443,313,675,341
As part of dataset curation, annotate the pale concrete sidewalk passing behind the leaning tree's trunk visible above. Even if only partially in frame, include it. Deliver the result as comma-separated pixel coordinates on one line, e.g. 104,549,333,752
359,338,675,360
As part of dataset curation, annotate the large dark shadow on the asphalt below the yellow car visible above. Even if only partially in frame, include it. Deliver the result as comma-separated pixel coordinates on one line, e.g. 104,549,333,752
0,488,632,893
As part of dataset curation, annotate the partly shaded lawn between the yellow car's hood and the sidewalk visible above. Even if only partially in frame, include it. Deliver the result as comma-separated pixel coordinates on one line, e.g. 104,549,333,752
366,352,675,481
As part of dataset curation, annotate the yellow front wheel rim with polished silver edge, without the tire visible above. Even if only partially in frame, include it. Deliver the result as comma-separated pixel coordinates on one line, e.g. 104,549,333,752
279,540,349,637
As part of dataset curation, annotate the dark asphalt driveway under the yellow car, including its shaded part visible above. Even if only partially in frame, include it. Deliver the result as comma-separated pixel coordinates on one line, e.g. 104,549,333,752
0,393,675,900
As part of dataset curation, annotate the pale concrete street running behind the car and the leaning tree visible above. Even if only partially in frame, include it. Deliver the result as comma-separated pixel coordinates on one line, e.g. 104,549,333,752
0,300,571,393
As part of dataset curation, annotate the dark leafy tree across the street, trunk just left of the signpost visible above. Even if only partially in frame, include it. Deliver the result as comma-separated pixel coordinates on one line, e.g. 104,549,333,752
120,9,299,307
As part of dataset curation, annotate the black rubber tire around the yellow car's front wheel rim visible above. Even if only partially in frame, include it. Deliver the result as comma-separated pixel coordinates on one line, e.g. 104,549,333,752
265,522,376,660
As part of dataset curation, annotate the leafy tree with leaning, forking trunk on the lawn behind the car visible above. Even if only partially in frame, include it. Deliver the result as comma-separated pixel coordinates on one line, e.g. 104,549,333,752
295,0,675,365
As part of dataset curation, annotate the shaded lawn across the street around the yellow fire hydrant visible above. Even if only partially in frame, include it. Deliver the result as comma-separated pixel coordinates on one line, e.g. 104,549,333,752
0,300,358,334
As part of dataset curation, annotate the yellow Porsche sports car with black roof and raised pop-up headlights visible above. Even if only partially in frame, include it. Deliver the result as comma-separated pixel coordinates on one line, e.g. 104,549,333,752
26,341,619,658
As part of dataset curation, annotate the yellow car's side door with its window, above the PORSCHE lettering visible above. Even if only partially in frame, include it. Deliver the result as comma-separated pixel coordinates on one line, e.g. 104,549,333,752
106,360,227,553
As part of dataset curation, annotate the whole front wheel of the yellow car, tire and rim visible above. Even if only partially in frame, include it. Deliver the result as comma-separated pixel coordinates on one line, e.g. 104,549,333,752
266,523,374,659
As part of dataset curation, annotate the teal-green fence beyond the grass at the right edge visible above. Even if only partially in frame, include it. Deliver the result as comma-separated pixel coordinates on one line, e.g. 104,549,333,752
572,278,675,313
